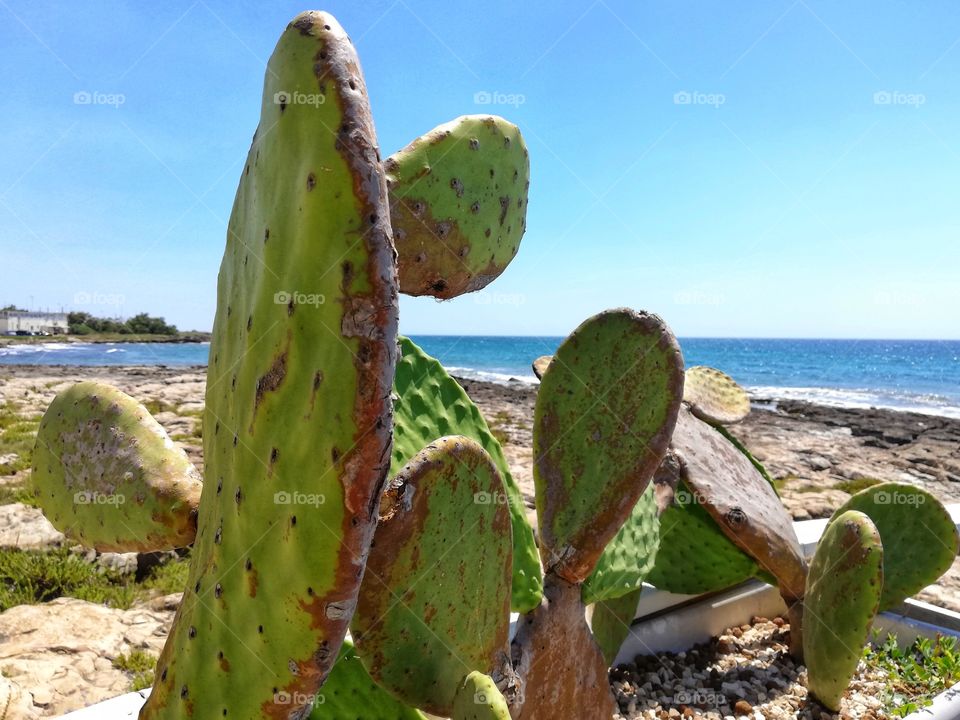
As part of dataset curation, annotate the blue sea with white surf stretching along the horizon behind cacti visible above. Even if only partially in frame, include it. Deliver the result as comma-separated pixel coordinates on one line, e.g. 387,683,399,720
0,335,960,418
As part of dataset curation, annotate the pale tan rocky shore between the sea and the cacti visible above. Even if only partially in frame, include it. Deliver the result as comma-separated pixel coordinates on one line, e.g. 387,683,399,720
0,365,960,717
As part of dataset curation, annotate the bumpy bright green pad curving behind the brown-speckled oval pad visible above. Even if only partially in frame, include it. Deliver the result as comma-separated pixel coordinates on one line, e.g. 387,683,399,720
390,338,543,612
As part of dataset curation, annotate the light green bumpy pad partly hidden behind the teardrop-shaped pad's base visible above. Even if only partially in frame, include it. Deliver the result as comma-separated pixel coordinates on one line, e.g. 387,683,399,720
582,483,660,605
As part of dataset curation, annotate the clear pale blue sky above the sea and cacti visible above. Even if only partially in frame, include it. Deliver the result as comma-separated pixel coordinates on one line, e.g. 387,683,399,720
0,0,960,338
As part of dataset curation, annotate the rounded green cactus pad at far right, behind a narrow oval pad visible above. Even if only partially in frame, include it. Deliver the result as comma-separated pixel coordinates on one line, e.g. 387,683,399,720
830,483,960,612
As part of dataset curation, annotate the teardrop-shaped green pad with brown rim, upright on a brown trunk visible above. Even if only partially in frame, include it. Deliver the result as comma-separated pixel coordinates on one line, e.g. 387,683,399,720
533,308,683,583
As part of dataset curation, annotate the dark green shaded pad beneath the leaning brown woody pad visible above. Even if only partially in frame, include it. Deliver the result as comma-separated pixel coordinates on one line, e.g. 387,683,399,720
646,482,760,595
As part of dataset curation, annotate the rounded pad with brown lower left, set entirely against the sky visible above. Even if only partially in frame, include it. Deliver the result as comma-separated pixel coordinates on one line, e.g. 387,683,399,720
383,115,530,298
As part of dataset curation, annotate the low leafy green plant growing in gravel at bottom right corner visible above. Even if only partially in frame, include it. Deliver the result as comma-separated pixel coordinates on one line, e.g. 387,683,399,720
863,635,960,717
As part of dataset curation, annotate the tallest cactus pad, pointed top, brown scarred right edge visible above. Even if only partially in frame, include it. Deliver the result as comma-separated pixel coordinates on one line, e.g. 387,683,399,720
141,12,397,720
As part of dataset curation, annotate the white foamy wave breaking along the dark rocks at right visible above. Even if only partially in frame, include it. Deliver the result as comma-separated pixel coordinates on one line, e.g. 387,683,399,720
747,385,960,419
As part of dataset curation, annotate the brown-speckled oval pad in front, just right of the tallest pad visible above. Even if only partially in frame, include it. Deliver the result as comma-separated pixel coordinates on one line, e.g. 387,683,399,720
352,436,511,716
